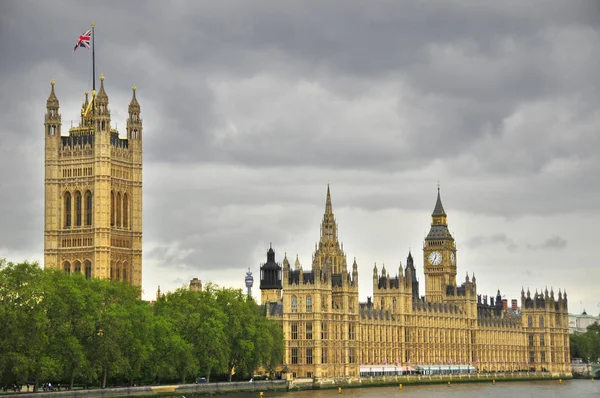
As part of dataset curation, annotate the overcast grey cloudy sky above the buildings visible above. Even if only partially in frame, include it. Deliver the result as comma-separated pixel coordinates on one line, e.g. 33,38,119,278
0,0,600,314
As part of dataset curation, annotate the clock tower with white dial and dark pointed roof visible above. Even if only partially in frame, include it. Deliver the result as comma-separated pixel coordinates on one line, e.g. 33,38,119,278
423,186,456,303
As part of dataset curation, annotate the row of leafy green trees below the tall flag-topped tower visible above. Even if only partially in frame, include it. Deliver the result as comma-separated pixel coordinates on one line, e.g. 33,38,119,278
0,259,283,388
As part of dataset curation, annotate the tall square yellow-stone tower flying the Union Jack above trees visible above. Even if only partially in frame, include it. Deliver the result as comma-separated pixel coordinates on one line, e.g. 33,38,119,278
44,76,142,286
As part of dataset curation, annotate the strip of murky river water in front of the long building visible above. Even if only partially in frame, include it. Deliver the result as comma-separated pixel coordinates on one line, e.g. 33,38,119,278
217,380,600,398
